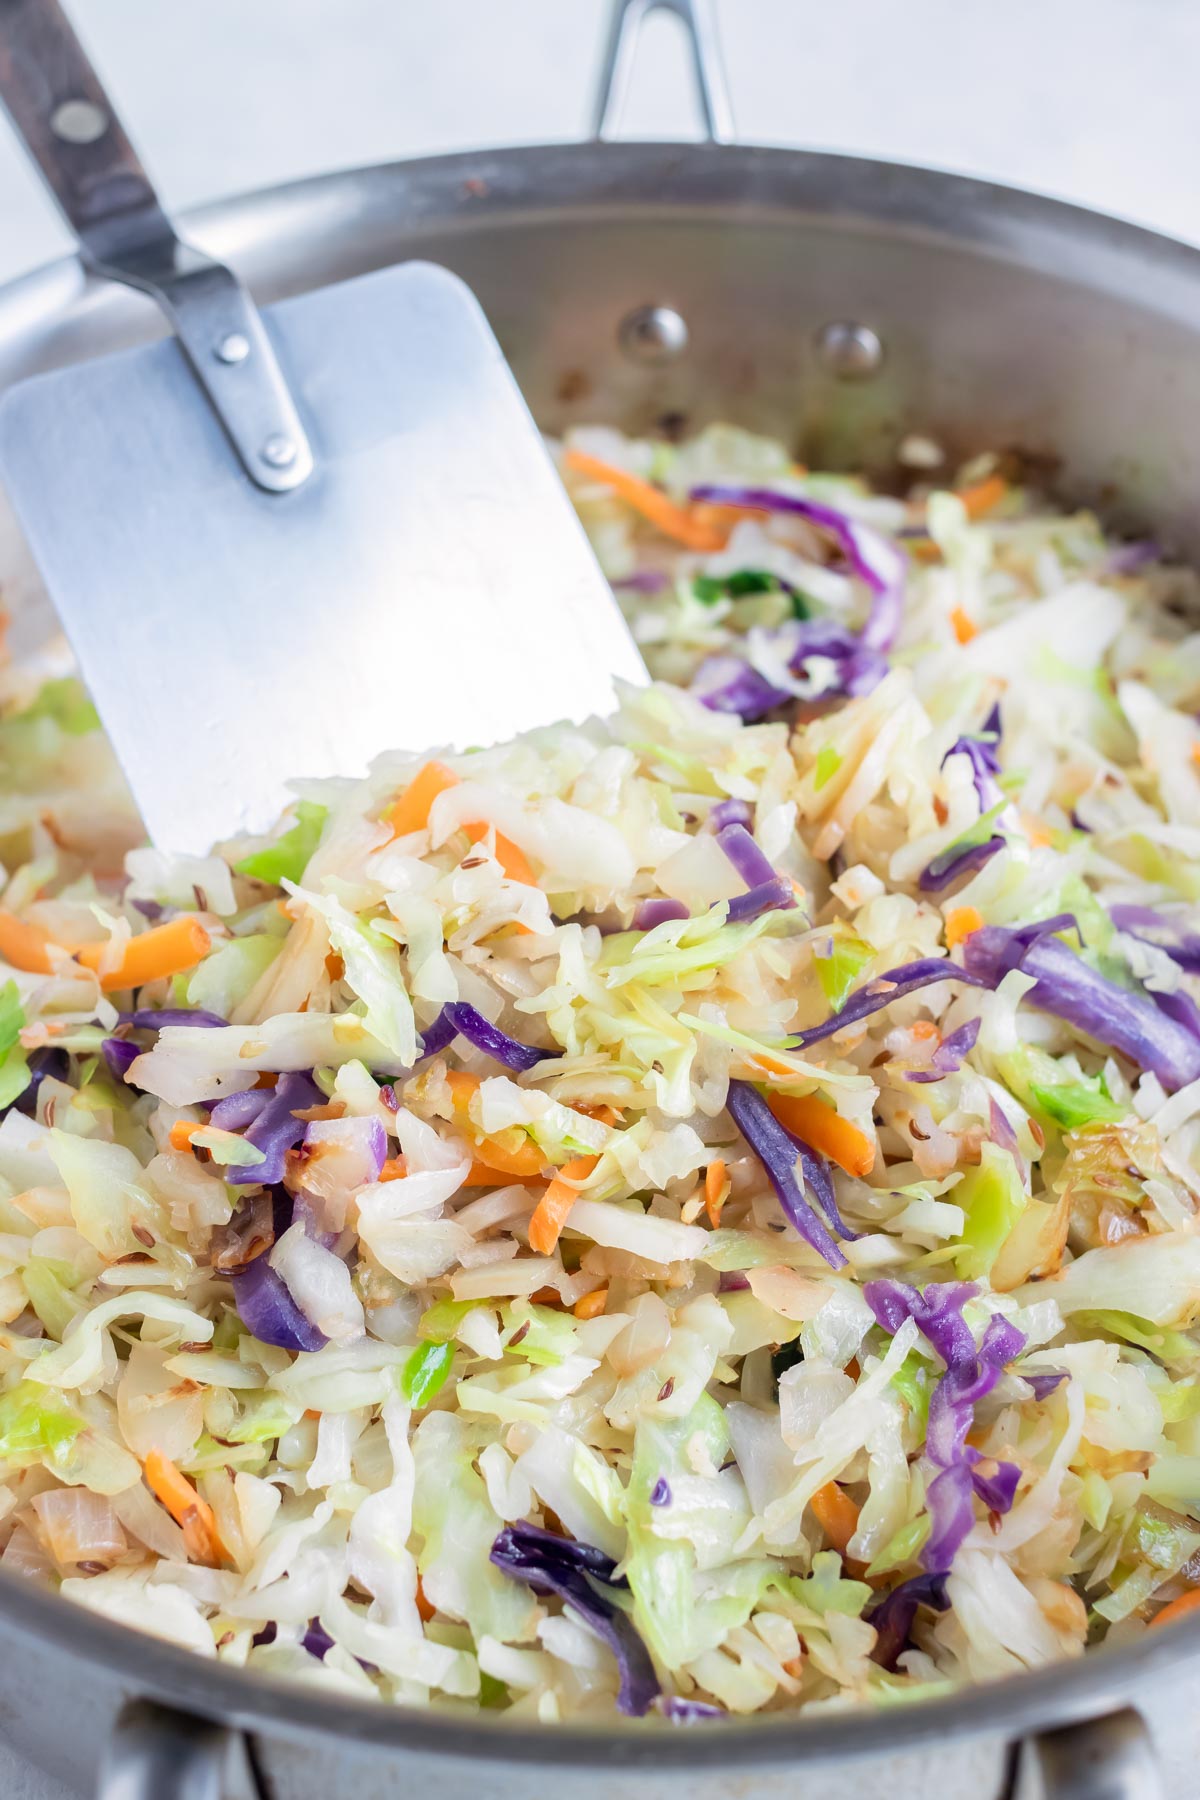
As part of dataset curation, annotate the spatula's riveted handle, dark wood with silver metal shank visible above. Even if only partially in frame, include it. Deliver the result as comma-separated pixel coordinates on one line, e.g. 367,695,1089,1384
0,0,313,493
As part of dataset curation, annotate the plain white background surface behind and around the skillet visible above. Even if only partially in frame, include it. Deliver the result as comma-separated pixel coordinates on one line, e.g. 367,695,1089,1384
0,0,1200,1800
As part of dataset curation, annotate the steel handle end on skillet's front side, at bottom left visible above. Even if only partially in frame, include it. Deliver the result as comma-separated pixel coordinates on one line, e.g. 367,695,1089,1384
95,1699,263,1800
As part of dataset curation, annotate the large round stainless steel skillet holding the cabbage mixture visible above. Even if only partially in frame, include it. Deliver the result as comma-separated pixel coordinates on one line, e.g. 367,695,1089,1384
0,0,1200,1800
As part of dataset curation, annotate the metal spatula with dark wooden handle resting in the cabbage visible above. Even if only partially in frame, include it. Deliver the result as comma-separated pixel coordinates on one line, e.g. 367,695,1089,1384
0,0,644,850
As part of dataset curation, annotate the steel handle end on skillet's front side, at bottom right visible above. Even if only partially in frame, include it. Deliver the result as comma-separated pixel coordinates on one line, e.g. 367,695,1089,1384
1011,1706,1164,1800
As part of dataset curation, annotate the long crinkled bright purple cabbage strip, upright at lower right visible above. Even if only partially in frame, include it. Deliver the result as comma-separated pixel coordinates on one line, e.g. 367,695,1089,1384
864,1280,1025,1575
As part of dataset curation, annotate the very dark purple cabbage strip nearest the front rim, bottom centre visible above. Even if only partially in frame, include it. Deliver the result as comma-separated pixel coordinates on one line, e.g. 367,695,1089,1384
491,1525,662,1719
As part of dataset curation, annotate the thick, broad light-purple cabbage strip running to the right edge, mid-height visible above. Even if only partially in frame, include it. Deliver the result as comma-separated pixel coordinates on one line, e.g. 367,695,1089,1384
963,914,1200,1093
